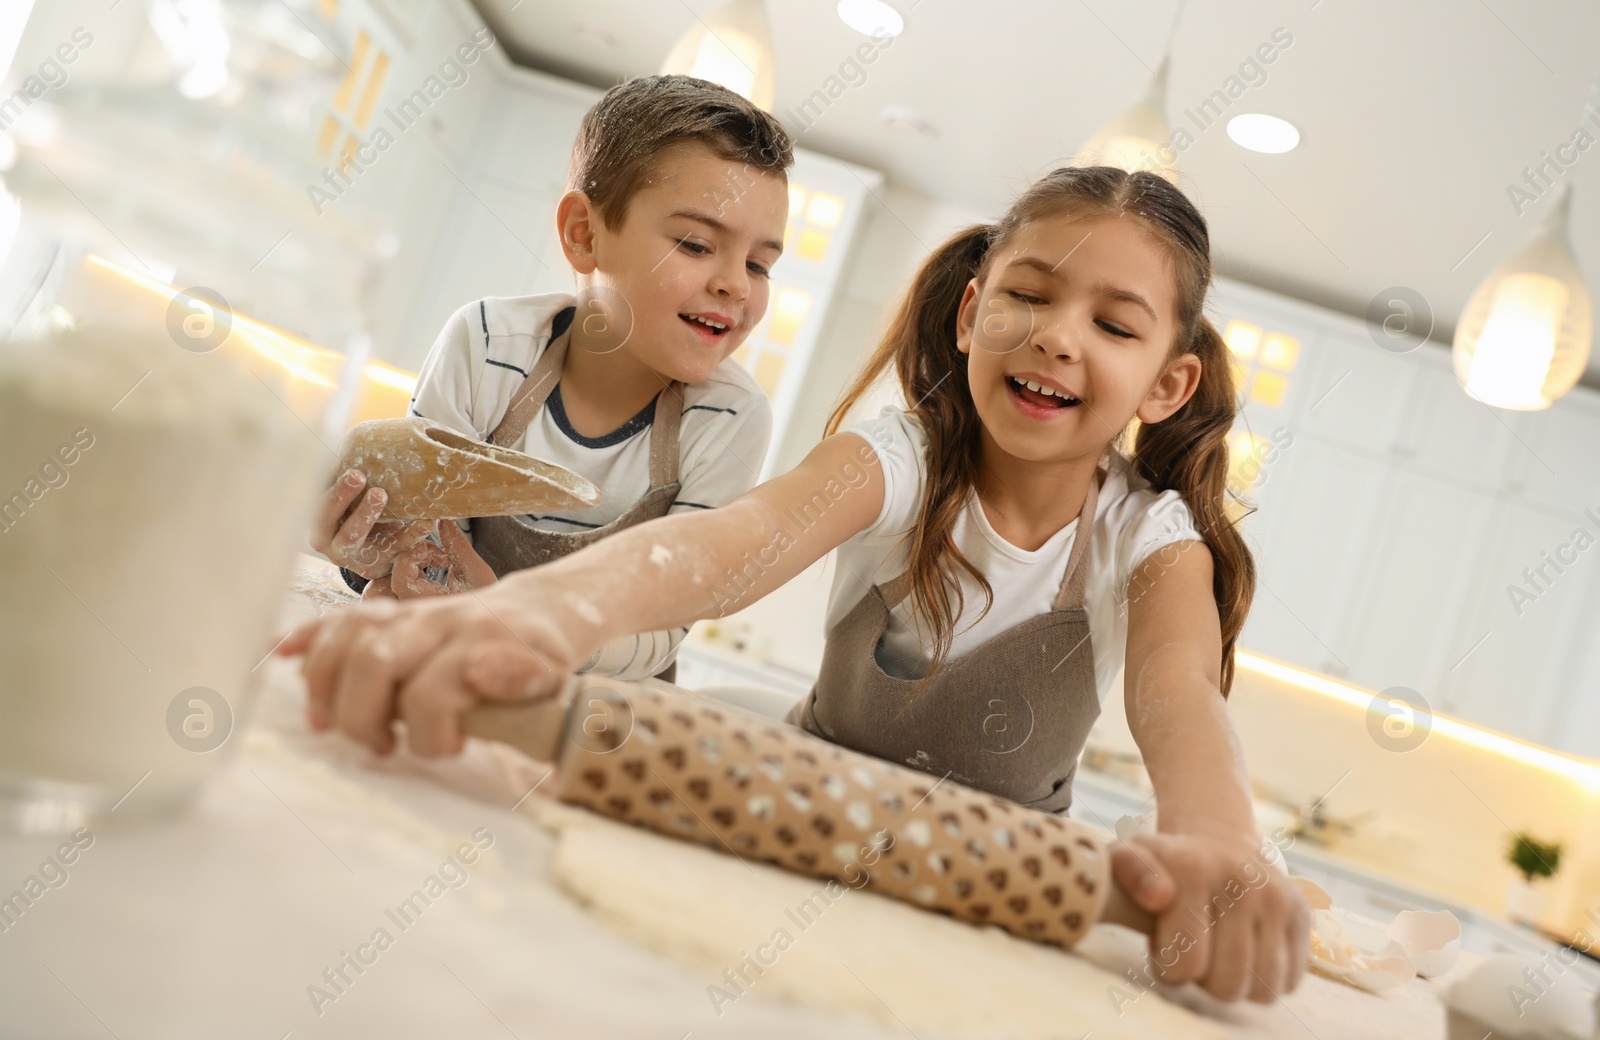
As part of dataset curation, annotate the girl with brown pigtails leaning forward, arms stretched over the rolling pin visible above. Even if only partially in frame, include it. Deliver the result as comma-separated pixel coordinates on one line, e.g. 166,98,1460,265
280,166,1309,1002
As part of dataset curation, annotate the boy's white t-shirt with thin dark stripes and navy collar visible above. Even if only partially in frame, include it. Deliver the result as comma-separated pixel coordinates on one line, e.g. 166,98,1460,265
411,293,773,678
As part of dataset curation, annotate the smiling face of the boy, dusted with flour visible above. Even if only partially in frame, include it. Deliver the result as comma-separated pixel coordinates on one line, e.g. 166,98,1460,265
574,141,789,382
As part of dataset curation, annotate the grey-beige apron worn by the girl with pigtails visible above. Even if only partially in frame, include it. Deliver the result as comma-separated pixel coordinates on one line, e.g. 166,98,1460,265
787,470,1104,813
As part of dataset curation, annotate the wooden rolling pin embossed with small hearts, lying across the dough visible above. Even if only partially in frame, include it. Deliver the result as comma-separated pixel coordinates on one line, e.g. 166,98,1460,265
464,675,1152,946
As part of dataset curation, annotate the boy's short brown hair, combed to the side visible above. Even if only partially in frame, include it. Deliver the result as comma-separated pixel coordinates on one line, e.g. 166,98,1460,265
566,75,794,227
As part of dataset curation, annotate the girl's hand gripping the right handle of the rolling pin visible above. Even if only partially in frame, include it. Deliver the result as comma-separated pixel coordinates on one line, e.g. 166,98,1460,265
1112,834,1310,1003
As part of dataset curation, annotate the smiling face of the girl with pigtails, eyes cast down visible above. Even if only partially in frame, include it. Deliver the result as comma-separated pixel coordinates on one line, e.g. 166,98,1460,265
957,216,1200,461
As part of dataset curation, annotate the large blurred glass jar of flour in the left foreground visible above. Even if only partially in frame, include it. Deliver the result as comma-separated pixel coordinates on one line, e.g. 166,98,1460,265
0,0,386,832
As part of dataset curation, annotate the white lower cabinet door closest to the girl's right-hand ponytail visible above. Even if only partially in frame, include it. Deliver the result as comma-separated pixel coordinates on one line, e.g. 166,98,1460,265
1240,434,1386,675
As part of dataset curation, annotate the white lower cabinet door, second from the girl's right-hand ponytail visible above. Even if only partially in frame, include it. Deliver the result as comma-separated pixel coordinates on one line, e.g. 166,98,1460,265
1341,467,1493,704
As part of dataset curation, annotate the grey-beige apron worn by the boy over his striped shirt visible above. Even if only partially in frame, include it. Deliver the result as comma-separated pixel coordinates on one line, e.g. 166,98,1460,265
472,323,683,682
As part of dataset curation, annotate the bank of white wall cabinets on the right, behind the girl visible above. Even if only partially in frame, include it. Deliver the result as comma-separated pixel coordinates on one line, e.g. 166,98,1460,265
1218,272,1600,755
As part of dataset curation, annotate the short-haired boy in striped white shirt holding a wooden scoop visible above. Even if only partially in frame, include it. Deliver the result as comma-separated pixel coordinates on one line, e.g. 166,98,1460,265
312,75,794,678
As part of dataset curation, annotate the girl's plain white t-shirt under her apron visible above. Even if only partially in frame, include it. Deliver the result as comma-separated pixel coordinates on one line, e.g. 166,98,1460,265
827,405,1200,702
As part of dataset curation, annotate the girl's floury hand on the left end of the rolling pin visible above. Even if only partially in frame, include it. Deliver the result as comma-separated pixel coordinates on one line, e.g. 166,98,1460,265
275,573,594,757
